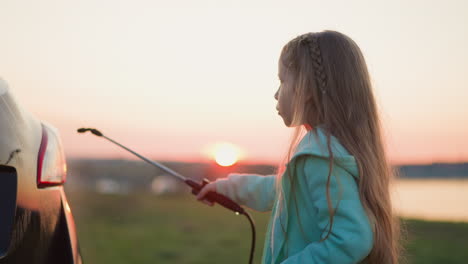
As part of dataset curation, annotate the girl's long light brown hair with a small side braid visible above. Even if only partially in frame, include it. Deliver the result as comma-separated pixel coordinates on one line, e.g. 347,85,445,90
272,30,400,264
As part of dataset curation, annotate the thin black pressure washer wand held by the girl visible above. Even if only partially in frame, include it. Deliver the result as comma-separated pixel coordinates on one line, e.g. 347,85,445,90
77,128,246,214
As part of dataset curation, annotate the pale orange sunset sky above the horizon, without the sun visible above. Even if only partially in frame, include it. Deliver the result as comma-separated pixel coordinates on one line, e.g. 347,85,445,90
0,0,468,163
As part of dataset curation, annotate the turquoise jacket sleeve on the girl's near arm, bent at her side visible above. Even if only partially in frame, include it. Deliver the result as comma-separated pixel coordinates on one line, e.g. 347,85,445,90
281,156,373,264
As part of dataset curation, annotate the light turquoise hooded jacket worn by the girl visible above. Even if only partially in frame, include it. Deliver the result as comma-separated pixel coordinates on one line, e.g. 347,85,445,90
215,126,373,264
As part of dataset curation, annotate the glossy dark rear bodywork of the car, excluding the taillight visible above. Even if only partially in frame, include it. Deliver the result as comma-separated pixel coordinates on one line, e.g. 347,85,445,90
0,79,81,263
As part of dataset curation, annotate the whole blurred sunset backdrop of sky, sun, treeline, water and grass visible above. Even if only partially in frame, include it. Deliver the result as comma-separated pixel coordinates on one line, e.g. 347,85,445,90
0,0,468,263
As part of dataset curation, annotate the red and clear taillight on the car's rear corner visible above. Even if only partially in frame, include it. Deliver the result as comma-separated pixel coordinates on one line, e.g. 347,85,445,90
37,124,67,188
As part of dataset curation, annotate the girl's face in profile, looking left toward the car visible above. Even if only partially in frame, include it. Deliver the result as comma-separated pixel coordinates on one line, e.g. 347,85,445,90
275,58,294,127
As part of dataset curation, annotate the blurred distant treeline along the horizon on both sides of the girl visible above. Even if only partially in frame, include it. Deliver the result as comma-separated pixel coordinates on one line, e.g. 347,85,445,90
68,159,468,183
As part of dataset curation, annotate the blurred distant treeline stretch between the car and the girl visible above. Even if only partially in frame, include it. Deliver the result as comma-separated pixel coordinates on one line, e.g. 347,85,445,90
67,159,276,191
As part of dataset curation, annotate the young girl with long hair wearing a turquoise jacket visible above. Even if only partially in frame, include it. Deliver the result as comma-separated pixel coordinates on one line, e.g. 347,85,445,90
197,30,399,264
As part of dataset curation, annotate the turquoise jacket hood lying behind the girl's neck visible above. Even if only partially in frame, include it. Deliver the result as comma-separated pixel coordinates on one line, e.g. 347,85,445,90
291,125,359,179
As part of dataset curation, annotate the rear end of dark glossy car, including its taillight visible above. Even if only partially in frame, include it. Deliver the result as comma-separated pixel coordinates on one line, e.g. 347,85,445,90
0,79,82,263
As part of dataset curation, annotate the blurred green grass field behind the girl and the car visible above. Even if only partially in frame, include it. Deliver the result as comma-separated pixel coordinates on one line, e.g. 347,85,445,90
68,192,468,264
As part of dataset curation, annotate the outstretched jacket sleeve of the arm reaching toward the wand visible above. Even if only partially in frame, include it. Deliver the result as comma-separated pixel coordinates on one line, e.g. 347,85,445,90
215,173,275,212
